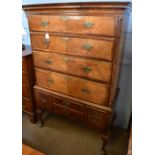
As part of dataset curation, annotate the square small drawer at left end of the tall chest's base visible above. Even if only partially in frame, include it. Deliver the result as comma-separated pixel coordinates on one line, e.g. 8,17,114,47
35,90,52,112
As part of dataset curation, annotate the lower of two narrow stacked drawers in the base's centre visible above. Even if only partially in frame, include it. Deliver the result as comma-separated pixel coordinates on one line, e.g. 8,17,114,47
53,104,83,121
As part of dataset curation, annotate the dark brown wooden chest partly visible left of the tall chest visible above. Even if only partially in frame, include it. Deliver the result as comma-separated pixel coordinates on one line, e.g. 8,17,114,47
22,48,36,123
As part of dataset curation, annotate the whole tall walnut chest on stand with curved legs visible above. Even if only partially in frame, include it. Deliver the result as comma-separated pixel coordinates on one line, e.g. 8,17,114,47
23,2,129,154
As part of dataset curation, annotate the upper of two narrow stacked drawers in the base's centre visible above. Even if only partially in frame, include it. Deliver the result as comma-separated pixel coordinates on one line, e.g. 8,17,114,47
53,96,83,112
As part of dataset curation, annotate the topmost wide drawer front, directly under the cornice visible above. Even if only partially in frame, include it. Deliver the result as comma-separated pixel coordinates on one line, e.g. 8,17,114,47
28,15,116,36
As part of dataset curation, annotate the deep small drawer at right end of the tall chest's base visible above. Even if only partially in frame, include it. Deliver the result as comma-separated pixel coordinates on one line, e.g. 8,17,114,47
85,108,110,132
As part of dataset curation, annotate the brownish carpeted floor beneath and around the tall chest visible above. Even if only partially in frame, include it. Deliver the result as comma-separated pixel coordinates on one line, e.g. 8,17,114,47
22,113,129,155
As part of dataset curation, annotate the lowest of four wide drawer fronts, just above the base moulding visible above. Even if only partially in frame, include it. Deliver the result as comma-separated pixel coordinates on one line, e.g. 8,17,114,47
35,69,109,105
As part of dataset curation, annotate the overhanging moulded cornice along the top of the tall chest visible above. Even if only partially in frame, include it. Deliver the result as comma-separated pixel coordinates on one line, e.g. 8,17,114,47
22,2,131,11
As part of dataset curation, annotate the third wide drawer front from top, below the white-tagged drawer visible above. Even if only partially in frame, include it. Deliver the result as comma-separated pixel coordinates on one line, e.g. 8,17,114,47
33,51,112,82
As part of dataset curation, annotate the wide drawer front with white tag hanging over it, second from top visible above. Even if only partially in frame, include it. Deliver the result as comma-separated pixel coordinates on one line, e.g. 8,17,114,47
31,33,114,61
